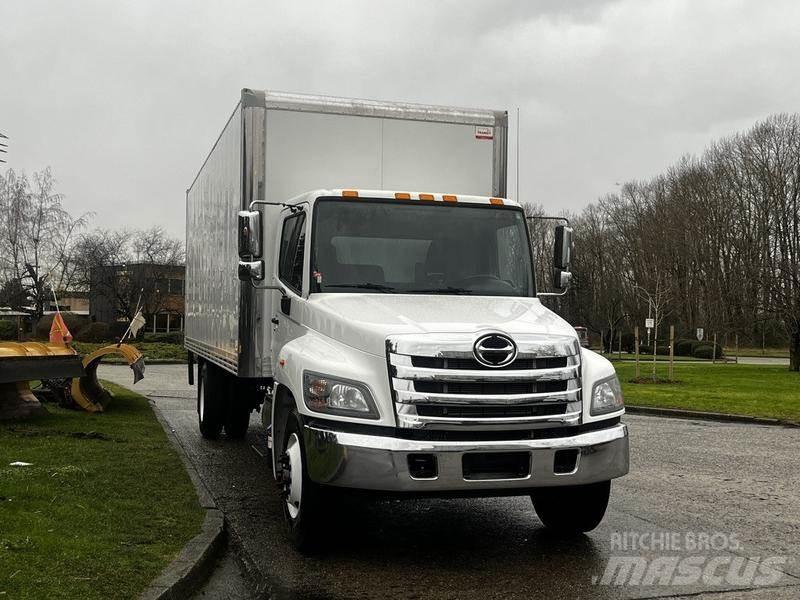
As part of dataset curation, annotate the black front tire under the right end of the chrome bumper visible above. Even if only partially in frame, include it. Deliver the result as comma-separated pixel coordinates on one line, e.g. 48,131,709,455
531,481,611,534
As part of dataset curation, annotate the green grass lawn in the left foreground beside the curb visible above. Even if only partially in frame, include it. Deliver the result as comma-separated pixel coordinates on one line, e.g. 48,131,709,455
0,384,204,600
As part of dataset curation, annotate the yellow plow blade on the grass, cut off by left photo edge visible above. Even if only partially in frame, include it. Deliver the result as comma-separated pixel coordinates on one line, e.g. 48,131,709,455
0,342,83,420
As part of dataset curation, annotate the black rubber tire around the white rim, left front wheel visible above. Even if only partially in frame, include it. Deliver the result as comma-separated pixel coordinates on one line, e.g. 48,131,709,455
279,410,322,552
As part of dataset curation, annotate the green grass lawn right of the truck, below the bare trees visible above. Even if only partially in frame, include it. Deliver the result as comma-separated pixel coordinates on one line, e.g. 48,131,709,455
615,363,800,422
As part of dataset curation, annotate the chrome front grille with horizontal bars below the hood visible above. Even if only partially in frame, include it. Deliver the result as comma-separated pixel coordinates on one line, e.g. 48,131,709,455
387,334,581,429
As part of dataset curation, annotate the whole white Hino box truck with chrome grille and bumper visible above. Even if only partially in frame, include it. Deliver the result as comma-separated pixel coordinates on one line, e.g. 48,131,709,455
186,89,629,548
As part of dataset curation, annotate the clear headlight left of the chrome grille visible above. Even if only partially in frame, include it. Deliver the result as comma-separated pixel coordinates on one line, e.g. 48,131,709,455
303,372,379,419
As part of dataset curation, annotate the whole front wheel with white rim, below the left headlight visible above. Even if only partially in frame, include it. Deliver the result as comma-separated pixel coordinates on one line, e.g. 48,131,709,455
279,411,321,551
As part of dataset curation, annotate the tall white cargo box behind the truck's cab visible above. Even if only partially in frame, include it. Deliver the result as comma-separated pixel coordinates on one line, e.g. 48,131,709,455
185,89,507,377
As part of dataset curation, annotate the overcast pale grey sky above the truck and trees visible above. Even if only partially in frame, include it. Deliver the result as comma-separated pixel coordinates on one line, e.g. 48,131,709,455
0,0,800,237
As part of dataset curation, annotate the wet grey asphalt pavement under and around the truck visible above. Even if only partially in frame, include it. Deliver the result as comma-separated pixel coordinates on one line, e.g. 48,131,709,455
100,365,800,600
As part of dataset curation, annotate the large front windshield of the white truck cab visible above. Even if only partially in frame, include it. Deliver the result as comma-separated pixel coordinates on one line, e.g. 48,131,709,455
311,199,533,296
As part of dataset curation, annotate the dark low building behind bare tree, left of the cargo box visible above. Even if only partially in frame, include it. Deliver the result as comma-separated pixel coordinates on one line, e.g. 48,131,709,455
89,263,186,333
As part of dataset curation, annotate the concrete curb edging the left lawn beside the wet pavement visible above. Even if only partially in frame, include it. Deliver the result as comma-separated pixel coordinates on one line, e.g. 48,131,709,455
139,400,226,600
